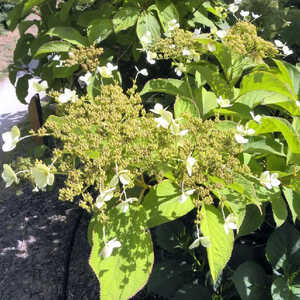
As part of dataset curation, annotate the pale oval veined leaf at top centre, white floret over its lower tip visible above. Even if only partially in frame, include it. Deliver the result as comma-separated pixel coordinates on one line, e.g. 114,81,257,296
136,12,161,47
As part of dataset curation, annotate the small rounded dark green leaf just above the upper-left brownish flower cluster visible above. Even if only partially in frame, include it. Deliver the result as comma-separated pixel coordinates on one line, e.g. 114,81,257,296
87,18,113,44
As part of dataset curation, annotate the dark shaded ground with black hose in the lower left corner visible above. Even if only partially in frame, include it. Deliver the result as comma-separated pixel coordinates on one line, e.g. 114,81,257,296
0,182,99,300
